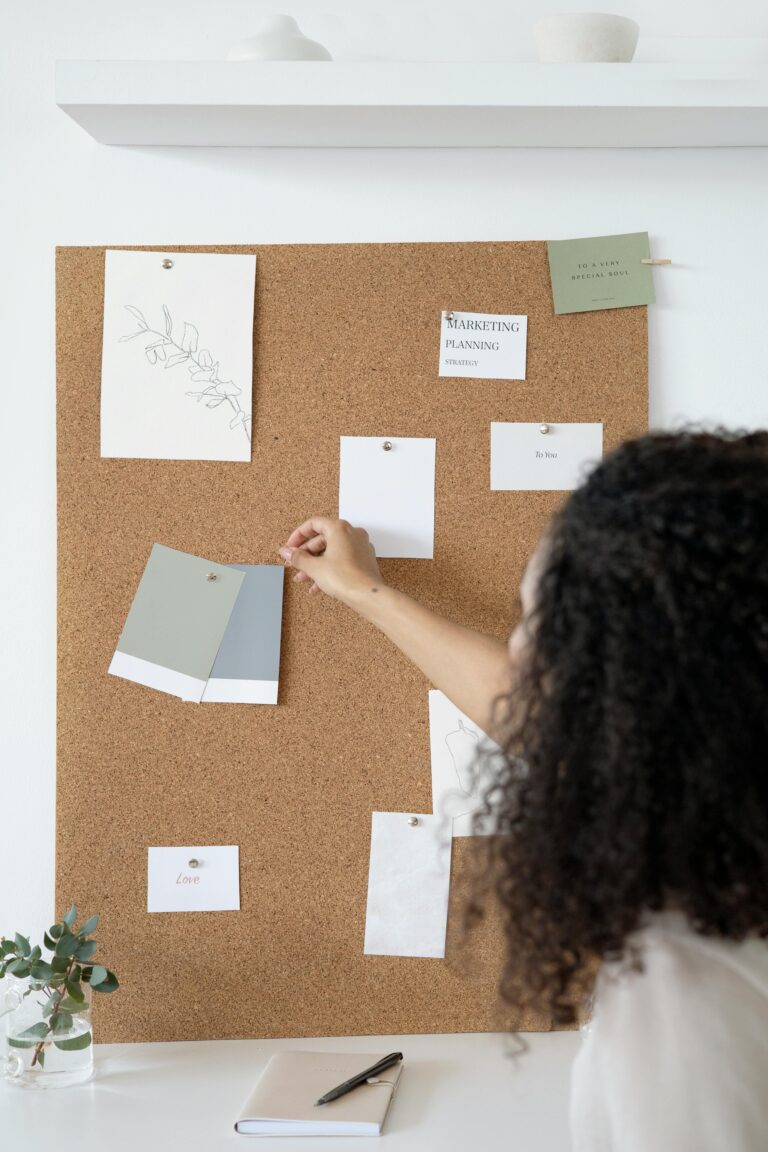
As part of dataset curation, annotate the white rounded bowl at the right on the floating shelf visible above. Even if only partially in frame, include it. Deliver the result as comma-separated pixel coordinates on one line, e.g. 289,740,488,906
533,12,640,63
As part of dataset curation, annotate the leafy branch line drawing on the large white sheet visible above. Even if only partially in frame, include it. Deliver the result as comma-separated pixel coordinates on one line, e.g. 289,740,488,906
120,304,251,442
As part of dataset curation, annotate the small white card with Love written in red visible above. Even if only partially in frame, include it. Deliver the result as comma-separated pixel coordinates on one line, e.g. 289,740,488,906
146,844,239,912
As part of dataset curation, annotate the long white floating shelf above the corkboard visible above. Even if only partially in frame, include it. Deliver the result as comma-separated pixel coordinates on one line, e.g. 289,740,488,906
56,60,768,147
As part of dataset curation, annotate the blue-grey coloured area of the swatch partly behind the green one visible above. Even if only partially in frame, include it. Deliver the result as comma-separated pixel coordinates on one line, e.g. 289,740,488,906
211,564,284,681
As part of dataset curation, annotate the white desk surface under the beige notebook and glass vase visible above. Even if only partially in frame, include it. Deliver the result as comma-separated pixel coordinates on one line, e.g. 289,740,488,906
0,1032,579,1152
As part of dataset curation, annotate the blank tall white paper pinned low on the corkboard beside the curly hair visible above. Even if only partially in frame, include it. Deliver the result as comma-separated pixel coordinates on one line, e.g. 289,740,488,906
364,812,451,956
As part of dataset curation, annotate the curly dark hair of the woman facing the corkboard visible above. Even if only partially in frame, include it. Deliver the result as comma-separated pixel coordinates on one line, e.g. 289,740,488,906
474,432,768,1025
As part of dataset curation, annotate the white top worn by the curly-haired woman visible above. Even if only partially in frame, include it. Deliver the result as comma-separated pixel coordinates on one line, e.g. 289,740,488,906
571,912,768,1152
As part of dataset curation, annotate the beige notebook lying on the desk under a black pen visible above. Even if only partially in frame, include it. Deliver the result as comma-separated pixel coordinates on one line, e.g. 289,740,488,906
235,1052,403,1136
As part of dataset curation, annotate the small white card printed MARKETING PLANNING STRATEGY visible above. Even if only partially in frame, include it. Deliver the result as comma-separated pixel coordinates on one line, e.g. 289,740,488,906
440,312,529,380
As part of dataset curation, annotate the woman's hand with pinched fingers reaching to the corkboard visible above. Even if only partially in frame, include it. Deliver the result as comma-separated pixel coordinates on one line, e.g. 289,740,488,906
280,516,383,605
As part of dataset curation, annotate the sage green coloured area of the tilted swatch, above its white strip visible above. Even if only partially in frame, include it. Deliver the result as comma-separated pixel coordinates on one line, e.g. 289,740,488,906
117,544,243,680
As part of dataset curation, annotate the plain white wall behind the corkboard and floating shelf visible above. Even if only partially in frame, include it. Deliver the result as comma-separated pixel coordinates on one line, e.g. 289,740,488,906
0,0,768,933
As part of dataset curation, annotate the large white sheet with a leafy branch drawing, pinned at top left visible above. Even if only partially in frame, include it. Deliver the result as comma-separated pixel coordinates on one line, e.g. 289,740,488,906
101,251,256,461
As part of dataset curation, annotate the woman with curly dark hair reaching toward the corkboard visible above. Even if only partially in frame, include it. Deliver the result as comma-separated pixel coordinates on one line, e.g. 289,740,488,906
281,433,768,1152
